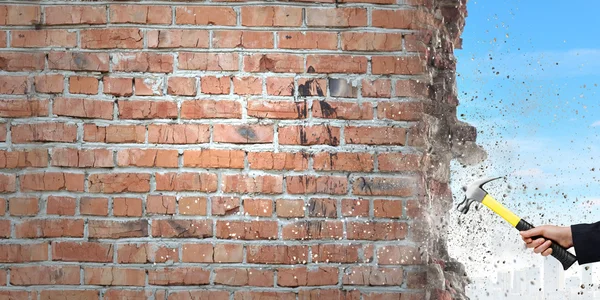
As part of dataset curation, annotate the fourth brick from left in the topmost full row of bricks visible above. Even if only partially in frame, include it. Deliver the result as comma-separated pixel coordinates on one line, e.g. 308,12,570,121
175,6,237,26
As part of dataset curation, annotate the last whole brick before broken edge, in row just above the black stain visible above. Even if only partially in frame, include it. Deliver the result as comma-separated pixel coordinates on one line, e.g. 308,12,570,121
371,56,425,75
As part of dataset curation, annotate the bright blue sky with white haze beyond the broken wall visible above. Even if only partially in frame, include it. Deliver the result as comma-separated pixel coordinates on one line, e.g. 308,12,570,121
449,0,600,286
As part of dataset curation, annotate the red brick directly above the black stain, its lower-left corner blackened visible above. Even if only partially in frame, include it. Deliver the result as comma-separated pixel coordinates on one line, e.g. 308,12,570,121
306,55,368,74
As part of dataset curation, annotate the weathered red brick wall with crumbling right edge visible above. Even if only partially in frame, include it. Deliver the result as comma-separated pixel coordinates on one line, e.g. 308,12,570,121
0,0,474,300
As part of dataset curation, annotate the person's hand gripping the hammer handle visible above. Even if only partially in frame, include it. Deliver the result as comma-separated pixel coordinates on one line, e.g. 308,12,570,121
521,225,573,256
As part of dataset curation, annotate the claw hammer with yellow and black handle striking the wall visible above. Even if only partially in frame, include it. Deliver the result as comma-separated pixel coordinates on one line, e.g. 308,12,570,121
457,177,577,270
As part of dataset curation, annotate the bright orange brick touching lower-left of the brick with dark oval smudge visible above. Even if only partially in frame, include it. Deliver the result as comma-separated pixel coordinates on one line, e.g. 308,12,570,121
183,149,245,169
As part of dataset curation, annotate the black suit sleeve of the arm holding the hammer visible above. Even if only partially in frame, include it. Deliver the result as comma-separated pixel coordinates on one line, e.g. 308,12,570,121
571,222,600,265
